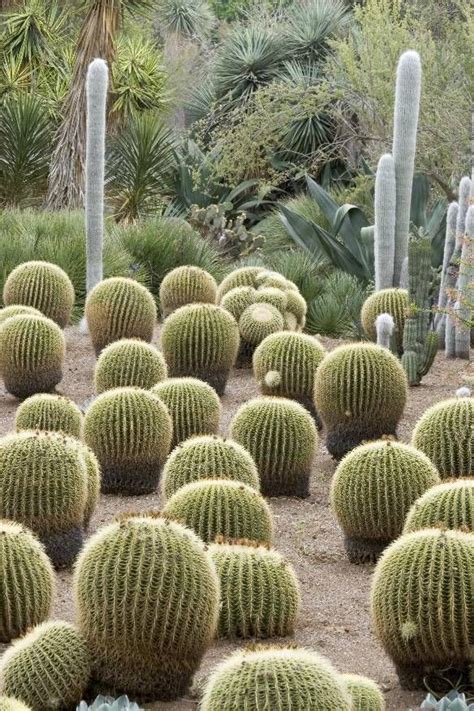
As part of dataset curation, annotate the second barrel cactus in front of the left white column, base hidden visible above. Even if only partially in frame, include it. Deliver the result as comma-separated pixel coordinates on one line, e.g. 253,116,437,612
94,338,167,394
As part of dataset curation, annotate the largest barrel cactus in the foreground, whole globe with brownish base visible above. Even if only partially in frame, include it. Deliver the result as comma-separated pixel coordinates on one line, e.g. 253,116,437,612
74,516,219,701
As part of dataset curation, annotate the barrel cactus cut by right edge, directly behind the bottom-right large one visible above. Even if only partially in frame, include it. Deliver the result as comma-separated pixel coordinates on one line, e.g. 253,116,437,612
404,479,474,533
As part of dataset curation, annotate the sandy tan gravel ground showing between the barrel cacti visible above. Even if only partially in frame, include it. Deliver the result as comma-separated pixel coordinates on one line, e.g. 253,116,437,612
0,329,472,711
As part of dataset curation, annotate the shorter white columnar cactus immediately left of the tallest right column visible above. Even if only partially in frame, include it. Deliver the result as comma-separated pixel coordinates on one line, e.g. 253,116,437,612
374,153,397,291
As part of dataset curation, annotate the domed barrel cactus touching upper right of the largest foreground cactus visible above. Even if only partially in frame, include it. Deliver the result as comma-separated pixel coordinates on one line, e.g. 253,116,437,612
163,479,273,544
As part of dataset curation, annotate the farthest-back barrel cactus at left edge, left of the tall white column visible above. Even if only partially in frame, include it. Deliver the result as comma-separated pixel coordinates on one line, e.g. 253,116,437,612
3,262,75,328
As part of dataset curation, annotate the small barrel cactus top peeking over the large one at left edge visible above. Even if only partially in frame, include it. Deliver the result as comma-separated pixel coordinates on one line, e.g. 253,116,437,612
15,393,82,438
